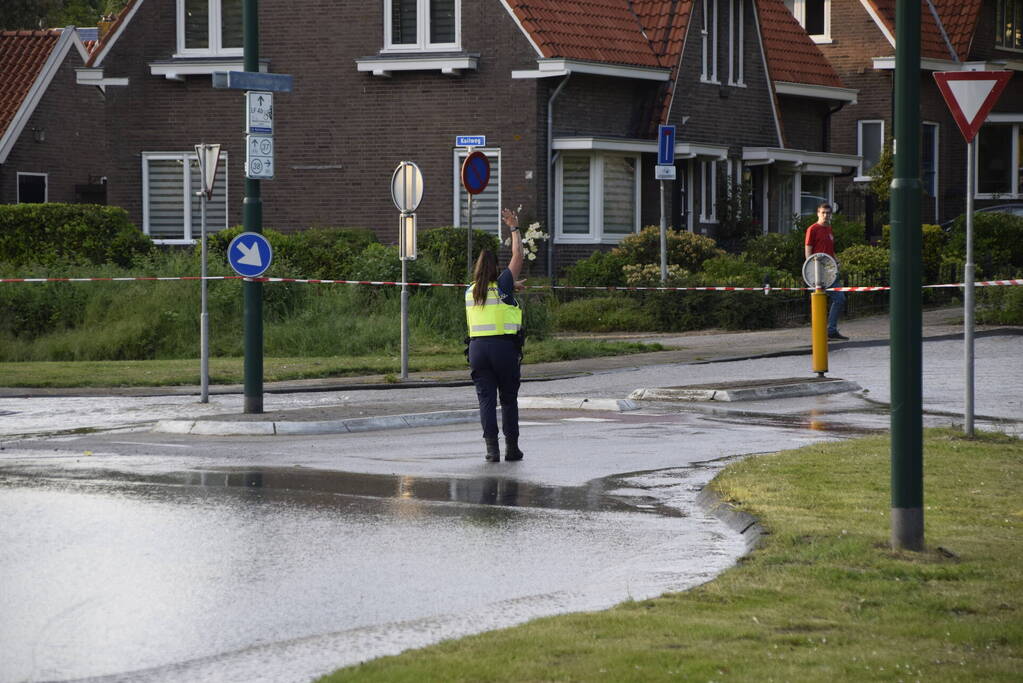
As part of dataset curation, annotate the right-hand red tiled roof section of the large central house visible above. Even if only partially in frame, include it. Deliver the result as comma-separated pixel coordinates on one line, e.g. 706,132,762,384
756,0,843,88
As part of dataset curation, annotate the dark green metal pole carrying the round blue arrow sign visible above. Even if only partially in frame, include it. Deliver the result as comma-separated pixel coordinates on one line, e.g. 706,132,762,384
241,0,263,413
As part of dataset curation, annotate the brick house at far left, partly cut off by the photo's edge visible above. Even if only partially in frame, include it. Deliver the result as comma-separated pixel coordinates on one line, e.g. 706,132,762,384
0,27,106,203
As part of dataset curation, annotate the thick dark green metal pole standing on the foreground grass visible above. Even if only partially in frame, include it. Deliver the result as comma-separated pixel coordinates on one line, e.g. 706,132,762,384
890,0,924,550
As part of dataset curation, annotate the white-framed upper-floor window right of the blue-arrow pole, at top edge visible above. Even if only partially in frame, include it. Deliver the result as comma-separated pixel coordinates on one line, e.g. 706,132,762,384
384,0,461,51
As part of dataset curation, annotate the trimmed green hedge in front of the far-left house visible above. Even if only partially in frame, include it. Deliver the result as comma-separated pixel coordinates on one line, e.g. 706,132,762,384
0,203,153,267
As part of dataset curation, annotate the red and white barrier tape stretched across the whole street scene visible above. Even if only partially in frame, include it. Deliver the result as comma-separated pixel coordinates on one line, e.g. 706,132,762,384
0,275,1023,294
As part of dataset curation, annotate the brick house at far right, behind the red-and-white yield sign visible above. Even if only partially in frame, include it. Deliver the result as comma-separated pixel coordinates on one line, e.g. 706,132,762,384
786,0,1023,223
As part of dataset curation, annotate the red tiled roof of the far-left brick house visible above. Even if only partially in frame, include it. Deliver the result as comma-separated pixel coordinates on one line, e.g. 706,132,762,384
0,29,60,137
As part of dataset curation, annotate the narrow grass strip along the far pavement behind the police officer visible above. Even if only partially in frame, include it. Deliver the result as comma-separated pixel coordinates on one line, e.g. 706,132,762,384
0,339,664,388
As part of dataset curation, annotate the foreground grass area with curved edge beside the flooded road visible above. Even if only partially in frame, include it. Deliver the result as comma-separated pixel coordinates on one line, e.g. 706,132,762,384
321,430,1023,683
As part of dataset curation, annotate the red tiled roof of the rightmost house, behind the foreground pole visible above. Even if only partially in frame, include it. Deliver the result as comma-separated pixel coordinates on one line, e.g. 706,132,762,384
866,0,982,59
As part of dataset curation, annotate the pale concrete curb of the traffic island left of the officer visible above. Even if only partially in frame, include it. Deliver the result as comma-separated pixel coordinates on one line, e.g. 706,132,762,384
151,408,480,437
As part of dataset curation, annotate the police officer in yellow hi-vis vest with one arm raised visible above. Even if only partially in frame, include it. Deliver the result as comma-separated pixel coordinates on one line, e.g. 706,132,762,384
465,209,525,462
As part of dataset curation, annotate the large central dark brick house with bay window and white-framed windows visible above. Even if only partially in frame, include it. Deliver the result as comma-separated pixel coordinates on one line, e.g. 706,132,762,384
58,0,859,269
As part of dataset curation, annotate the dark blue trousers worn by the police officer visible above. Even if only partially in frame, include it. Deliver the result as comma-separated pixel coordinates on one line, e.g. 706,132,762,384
469,336,521,439
